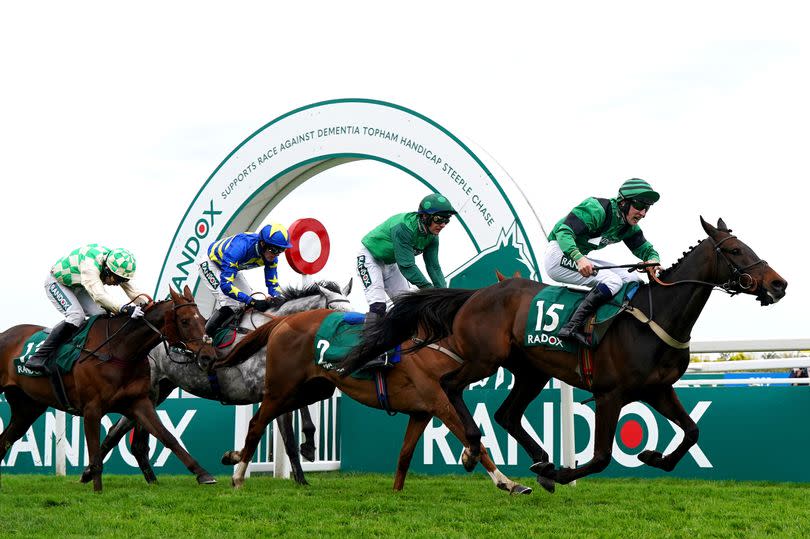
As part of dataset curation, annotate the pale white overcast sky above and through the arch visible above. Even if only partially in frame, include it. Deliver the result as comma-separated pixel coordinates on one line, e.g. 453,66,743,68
0,1,810,340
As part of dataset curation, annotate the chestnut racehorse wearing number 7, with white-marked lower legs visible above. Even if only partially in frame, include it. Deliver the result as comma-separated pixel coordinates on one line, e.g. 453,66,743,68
213,310,531,494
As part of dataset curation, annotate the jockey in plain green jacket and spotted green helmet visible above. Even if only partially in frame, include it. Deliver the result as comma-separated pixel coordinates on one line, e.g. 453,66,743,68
357,194,457,324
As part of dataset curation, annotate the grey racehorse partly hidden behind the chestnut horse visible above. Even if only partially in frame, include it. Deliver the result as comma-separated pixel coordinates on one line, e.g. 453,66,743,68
81,279,352,484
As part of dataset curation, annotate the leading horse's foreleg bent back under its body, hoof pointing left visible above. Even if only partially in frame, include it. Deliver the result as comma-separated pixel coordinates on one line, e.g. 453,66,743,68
542,392,624,485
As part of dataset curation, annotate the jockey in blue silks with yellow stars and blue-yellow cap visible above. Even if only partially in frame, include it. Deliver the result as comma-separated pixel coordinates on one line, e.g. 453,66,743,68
197,223,292,337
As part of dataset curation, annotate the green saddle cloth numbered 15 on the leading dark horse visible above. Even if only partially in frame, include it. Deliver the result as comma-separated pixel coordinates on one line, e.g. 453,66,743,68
523,282,639,354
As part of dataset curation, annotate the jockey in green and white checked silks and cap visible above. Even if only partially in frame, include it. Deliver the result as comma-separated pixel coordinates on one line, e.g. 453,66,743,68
26,243,149,373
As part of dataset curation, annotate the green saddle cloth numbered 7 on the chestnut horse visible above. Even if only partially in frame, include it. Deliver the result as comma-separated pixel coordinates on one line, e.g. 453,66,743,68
314,312,401,379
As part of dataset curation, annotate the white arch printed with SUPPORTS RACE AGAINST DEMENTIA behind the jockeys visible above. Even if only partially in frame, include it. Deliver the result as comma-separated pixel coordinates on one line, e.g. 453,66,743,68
155,99,545,308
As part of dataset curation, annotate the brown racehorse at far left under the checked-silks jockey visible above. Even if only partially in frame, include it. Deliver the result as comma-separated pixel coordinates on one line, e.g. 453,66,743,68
0,287,216,491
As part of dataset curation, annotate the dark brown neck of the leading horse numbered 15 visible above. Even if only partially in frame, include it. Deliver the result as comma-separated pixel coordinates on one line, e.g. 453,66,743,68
648,241,716,340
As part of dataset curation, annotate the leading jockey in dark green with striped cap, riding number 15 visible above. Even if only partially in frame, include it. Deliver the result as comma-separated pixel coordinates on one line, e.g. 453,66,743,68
544,178,660,346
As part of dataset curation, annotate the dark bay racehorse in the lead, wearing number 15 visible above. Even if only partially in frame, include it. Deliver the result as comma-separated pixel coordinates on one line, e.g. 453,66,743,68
341,218,787,491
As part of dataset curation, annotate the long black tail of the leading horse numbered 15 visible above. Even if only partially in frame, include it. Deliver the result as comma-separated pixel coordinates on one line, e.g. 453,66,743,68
338,288,476,376
